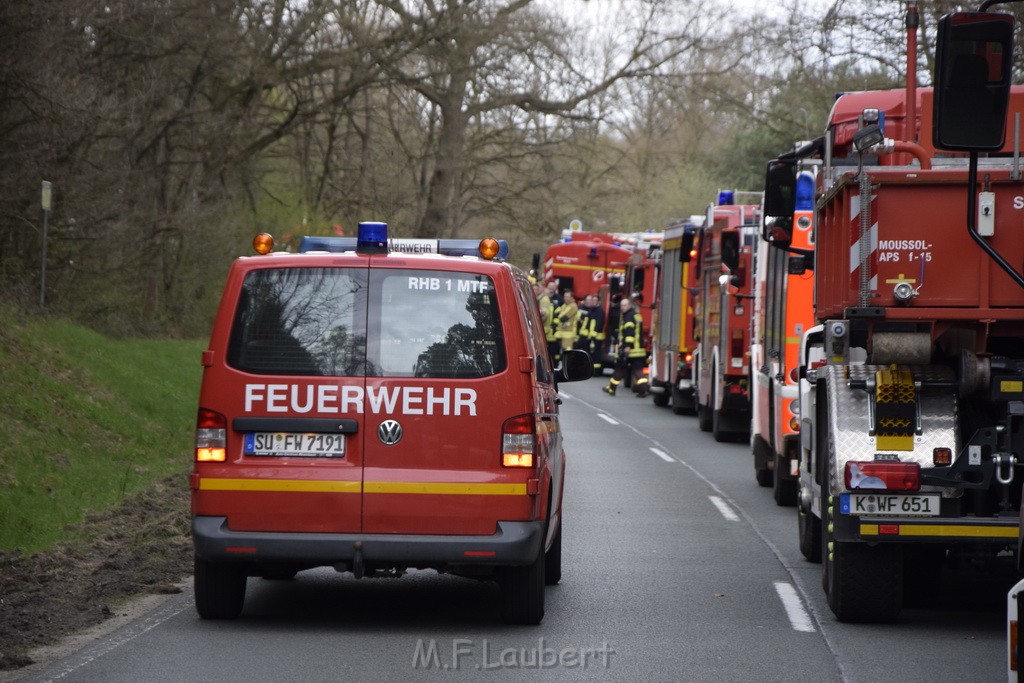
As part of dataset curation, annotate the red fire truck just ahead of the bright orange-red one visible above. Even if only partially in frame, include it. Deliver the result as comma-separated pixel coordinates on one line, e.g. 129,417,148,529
694,190,761,441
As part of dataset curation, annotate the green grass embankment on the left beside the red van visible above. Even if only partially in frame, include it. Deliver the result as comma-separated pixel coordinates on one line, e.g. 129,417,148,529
0,306,204,553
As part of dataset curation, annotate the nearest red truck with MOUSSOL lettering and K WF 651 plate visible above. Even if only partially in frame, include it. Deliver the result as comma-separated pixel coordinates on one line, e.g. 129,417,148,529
765,6,1024,622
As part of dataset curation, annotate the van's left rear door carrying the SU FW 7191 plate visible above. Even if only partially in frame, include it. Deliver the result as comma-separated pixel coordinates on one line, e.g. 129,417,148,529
207,258,368,532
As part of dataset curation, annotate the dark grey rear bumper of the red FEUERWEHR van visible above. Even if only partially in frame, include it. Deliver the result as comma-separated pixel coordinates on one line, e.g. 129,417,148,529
191,516,545,568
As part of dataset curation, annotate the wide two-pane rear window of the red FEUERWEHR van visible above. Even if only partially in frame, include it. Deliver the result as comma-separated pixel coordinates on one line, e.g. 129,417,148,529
227,268,506,378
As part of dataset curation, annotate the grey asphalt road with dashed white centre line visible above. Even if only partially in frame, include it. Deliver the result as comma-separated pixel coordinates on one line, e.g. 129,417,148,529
24,379,1009,683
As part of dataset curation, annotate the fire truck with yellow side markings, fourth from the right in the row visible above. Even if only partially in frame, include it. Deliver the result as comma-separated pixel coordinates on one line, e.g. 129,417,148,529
650,216,705,415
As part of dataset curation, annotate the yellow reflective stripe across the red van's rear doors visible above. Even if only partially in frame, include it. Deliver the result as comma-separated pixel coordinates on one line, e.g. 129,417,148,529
199,477,526,496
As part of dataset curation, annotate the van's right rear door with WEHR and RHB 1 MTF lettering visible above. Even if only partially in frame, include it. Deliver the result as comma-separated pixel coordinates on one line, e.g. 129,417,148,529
361,259,536,535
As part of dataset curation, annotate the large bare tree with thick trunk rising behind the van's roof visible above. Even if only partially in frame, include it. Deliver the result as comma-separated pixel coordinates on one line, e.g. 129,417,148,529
378,0,697,239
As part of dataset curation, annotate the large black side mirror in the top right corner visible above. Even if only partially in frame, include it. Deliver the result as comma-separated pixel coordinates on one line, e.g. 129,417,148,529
932,12,1014,152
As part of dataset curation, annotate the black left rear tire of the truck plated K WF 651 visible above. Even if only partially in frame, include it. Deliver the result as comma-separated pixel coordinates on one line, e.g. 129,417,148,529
821,511,903,624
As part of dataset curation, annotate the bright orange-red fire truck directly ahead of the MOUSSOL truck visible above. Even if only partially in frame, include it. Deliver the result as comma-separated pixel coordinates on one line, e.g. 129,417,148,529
751,156,820,505
